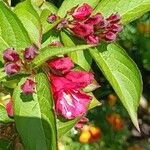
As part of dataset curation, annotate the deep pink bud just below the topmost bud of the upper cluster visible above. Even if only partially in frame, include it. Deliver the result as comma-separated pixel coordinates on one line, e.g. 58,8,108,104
70,22,94,37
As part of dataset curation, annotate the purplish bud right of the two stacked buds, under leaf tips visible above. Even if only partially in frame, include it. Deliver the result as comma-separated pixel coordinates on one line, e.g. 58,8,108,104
24,45,38,61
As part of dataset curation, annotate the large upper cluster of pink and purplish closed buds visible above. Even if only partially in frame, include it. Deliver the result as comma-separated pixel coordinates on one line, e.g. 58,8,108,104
48,3,122,44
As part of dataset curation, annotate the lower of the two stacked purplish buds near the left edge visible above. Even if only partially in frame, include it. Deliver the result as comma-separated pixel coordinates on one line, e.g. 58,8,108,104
5,63,20,75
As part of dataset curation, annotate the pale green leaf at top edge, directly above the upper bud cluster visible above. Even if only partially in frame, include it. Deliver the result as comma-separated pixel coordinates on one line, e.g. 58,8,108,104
58,0,100,18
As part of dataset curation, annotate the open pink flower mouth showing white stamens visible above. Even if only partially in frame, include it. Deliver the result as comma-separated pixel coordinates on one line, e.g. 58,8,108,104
54,90,91,119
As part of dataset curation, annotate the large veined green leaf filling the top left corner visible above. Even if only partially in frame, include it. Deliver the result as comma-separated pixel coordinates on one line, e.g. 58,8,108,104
0,1,31,52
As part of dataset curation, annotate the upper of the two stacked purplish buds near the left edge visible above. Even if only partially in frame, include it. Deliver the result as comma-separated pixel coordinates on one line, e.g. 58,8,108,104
3,48,20,62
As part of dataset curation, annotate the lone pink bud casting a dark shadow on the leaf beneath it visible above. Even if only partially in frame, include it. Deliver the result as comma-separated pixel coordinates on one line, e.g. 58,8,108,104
21,79,35,94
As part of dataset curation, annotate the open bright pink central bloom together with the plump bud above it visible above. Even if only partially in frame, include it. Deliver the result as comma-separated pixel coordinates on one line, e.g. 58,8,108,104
47,57,94,119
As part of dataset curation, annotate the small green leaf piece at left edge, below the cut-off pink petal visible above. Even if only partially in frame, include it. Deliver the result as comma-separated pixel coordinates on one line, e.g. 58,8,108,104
0,104,13,123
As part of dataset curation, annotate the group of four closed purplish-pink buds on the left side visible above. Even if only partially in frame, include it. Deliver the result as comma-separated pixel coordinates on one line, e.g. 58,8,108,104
3,45,38,94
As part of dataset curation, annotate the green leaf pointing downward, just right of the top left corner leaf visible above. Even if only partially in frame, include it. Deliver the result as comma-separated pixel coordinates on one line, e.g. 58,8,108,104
14,1,42,47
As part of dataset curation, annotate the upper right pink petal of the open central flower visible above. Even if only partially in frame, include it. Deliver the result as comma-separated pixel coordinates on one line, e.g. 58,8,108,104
65,71,94,88
